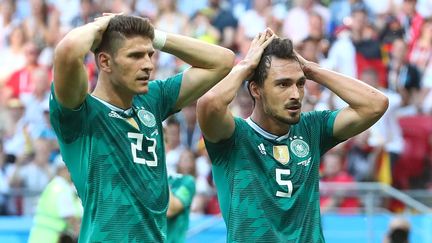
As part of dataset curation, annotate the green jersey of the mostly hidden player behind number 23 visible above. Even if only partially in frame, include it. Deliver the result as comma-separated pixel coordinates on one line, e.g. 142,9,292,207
167,174,195,243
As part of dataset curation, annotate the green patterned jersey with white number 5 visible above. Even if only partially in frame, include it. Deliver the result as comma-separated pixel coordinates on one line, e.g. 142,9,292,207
206,111,339,243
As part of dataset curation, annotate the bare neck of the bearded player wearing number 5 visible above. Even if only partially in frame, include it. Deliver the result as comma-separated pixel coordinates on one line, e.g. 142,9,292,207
250,106,291,136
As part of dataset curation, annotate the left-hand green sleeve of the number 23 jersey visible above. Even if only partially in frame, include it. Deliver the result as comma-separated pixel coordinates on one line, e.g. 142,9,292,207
49,83,88,144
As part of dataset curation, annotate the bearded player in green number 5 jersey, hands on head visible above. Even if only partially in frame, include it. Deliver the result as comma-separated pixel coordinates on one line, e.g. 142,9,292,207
197,30,388,242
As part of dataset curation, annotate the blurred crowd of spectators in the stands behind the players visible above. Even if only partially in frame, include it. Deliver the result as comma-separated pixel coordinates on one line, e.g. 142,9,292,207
0,0,432,215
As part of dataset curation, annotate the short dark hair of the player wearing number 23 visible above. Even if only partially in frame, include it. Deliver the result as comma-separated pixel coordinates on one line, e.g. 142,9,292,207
95,15,154,55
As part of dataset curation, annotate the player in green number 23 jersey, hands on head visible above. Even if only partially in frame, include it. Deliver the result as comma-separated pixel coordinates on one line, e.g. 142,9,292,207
50,14,234,242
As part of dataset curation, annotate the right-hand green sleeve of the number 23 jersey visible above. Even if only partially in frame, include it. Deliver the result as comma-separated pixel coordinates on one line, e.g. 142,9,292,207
146,73,183,120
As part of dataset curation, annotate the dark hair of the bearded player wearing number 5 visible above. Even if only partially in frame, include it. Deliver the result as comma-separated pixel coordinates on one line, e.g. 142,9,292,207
250,38,298,87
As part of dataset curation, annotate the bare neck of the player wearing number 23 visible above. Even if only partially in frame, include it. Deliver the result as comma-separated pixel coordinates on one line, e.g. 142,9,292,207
92,75,134,110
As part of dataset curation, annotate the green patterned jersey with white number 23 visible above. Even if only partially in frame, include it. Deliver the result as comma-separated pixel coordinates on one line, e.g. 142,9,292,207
50,73,182,242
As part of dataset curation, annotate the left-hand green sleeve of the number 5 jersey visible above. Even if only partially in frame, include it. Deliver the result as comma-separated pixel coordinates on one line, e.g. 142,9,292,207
204,117,243,165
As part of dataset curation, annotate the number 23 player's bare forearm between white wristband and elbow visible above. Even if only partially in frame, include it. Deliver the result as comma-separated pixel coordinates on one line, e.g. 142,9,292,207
162,33,233,69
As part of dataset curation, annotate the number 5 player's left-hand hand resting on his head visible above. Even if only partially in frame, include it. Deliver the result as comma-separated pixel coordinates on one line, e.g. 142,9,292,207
242,28,276,79
